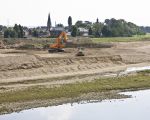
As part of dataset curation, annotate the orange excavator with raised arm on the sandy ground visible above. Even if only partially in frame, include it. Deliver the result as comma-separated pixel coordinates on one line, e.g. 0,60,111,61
48,31,68,53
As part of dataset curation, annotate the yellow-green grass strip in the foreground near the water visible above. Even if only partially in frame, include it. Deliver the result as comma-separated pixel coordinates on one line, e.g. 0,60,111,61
0,72,150,103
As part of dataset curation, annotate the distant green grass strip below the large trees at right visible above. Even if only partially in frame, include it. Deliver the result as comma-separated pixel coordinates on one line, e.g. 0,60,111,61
91,34,150,43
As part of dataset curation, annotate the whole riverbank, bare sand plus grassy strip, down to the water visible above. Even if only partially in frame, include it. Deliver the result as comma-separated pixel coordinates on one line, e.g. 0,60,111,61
0,41,150,114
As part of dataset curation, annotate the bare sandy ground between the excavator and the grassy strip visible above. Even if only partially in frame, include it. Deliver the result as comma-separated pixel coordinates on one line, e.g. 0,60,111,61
0,41,150,91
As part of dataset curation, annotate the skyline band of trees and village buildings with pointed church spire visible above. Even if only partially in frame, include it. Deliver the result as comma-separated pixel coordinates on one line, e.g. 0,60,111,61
0,15,146,38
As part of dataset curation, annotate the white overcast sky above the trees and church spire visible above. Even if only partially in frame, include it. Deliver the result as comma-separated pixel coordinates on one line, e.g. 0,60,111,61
0,0,150,26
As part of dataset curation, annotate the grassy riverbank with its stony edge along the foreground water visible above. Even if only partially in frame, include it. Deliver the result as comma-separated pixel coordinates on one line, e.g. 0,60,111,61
0,70,150,114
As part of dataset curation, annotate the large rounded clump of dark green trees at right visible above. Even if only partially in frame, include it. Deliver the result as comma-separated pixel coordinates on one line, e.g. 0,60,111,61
102,18,144,37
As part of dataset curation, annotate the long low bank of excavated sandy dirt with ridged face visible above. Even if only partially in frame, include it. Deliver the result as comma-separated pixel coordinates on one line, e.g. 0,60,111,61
0,55,123,79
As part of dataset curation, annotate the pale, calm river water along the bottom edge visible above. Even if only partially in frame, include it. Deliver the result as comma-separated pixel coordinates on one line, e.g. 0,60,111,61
0,90,150,120
